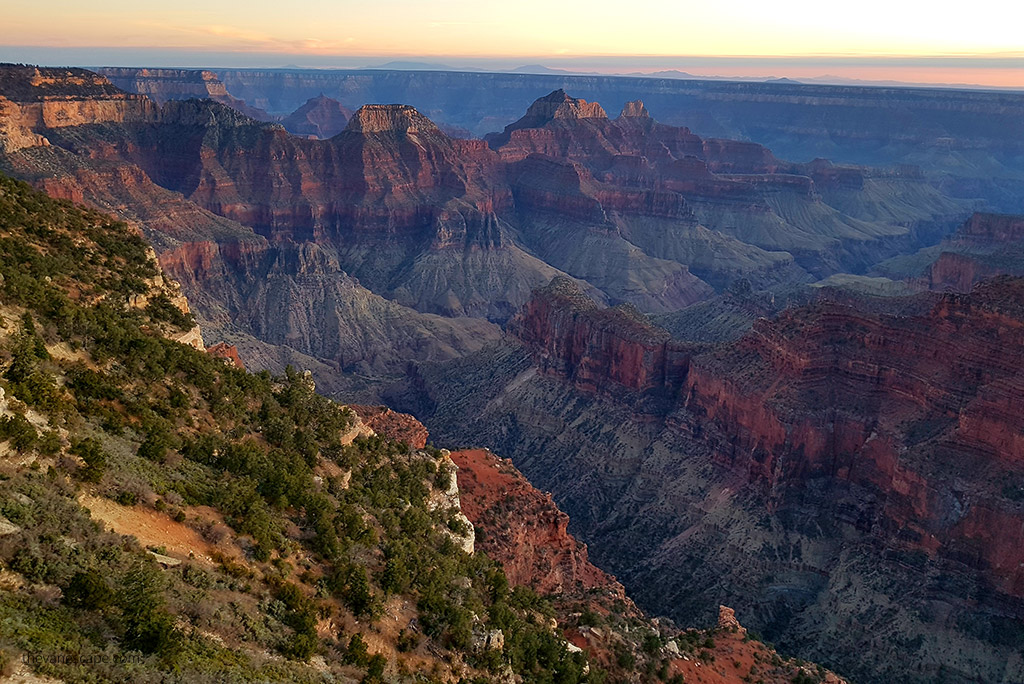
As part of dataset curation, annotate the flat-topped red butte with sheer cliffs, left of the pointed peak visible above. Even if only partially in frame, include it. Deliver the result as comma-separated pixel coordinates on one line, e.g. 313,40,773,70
118,96,558,319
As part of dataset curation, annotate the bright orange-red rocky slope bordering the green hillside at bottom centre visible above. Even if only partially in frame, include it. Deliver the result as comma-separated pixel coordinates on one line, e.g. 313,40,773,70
452,450,845,684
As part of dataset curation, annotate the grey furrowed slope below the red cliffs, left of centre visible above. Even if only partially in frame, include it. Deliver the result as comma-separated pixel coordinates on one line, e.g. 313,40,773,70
156,237,498,374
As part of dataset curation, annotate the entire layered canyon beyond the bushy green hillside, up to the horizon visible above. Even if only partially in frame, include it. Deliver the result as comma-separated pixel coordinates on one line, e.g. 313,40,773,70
0,62,1024,683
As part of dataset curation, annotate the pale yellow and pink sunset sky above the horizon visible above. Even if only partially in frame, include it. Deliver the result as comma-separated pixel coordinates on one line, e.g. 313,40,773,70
0,0,1024,88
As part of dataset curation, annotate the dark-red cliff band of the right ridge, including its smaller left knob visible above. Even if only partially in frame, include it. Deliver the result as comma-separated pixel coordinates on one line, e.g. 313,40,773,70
509,280,1024,598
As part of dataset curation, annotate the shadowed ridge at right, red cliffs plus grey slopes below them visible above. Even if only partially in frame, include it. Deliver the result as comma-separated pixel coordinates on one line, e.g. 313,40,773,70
405,280,1024,682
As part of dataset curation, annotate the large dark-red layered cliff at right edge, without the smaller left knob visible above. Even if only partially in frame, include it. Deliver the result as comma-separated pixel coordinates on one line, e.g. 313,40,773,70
683,280,1024,599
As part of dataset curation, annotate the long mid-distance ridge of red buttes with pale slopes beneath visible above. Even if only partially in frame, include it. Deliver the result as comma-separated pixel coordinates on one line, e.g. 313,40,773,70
0,72,957,335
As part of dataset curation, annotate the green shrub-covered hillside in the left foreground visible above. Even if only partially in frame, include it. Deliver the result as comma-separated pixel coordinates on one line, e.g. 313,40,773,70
0,177,602,683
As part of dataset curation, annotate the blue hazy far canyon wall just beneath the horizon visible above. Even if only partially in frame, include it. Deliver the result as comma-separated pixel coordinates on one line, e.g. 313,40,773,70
205,70,1024,213
